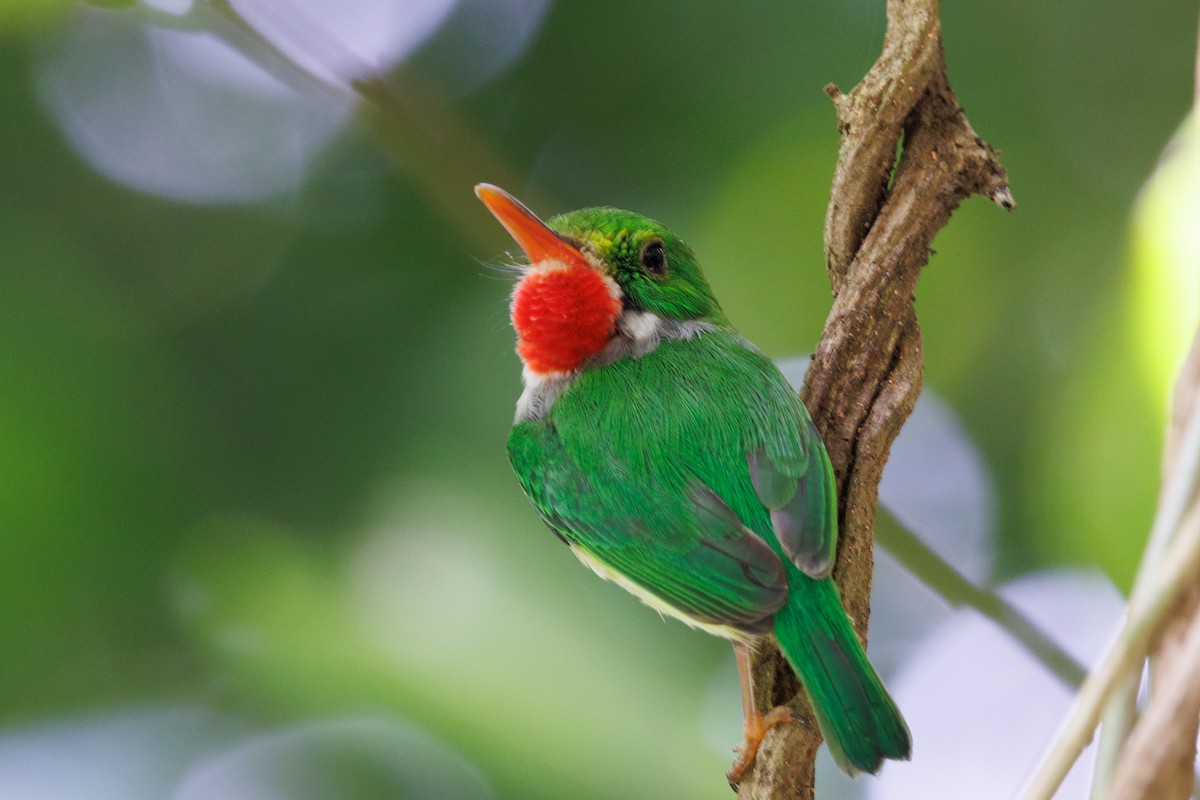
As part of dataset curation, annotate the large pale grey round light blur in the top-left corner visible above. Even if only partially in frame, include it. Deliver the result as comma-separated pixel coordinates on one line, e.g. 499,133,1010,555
35,10,352,204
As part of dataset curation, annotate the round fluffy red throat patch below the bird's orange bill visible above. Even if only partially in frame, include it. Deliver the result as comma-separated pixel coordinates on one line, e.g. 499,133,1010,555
512,266,620,375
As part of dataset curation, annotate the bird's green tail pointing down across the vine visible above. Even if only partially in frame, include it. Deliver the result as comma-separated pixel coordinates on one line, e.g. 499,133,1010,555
775,572,912,775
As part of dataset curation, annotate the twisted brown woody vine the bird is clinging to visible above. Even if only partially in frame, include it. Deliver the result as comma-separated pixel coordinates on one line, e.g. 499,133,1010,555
738,0,1015,800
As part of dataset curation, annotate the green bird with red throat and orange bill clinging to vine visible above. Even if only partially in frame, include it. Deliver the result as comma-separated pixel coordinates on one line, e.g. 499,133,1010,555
475,184,912,783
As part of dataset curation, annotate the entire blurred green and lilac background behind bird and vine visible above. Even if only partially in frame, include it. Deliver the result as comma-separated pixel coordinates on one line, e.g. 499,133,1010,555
0,0,1200,800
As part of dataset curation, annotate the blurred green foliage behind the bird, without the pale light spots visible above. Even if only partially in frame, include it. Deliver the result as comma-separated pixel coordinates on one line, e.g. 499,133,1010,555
0,0,1198,799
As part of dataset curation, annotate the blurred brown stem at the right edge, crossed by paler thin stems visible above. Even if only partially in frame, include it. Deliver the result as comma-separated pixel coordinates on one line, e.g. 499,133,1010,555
1108,333,1200,800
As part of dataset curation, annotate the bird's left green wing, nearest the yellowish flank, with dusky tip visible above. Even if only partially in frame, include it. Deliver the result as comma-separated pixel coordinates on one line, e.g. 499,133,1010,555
509,422,787,633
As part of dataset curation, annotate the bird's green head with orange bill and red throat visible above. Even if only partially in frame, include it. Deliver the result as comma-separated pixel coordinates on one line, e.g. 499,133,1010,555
475,184,727,378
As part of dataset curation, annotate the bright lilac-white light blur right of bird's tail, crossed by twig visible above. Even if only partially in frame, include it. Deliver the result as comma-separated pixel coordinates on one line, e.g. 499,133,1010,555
865,572,1124,800
